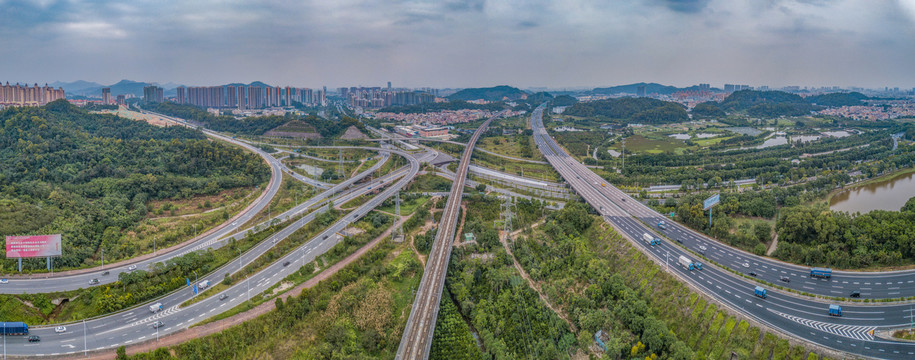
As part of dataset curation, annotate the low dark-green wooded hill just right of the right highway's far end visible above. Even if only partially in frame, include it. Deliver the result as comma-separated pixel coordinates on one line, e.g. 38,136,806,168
563,98,689,124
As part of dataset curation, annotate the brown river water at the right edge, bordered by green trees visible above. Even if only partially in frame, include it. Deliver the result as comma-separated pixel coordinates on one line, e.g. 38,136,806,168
829,173,915,214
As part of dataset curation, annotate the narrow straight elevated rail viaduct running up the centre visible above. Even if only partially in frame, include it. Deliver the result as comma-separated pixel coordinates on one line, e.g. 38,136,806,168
395,114,501,360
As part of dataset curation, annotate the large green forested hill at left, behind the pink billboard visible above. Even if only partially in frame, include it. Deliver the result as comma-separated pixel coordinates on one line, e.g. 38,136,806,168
0,100,270,271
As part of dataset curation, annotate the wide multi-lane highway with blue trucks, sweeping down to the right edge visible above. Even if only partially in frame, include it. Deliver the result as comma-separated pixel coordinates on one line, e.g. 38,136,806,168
531,106,915,359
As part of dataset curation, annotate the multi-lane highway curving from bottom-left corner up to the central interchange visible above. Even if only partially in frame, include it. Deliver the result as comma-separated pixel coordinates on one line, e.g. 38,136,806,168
4,143,419,356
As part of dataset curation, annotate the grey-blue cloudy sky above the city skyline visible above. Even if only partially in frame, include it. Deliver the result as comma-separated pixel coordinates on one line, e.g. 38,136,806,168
0,0,915,88
